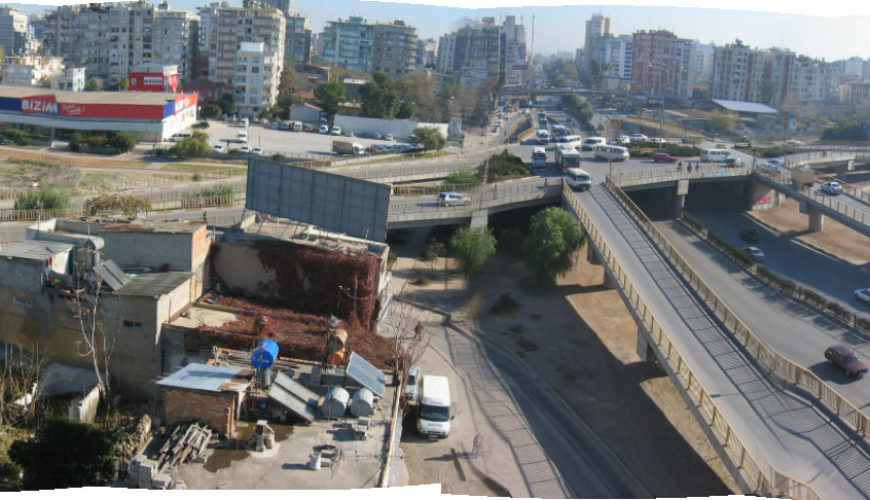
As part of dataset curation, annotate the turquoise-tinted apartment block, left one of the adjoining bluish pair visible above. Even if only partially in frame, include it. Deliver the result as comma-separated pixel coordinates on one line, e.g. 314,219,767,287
318,16,375,74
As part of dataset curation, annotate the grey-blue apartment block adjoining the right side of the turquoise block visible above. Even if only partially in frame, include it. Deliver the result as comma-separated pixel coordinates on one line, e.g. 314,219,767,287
371,19,417,80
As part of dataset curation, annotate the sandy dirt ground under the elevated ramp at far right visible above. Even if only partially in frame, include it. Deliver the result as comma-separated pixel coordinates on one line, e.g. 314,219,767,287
748,199,870,266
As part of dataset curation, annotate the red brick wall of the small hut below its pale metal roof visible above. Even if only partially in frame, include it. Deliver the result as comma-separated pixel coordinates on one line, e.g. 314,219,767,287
163,387,239,436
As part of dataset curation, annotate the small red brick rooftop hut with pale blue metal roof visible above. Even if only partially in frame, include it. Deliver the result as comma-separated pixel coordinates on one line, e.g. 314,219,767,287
157,363,252,436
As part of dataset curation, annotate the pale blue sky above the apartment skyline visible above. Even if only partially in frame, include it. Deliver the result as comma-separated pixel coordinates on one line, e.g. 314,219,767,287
8,0,870,61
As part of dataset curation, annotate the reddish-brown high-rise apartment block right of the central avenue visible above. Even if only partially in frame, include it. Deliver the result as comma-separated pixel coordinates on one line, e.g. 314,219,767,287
631,30,694,97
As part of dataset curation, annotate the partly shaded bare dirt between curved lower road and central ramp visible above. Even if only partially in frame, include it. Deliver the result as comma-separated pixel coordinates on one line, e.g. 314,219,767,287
409,249,739,497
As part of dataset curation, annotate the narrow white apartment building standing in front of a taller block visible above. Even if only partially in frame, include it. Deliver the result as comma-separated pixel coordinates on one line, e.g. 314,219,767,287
233,42,283,116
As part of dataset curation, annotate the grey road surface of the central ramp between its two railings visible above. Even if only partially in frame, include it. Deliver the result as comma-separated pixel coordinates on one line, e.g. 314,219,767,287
566,186,870,499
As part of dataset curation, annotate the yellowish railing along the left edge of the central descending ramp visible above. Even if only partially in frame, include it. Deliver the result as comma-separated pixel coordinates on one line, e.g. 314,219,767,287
562,186,821,500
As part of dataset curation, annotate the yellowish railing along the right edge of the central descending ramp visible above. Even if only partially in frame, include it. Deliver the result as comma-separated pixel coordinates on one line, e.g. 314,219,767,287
608,176,870,496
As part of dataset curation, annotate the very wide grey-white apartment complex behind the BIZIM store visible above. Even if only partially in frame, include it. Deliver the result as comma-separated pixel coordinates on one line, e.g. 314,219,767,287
44,0,199,82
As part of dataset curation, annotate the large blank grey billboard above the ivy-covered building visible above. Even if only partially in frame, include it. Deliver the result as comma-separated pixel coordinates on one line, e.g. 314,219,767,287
245,158,391,241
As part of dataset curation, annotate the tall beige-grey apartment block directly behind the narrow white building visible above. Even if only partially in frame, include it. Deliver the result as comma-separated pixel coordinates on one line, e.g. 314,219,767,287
208,7,287,94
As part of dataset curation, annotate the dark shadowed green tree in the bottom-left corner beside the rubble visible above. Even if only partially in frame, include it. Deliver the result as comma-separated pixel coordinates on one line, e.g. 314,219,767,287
9,418,116,490
